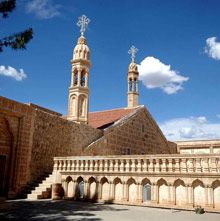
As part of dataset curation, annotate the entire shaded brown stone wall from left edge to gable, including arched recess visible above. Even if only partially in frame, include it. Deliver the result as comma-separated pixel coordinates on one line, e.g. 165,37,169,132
0,97,103,198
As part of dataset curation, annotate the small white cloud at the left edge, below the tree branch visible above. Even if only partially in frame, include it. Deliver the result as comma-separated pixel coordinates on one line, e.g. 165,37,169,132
0,65,27,81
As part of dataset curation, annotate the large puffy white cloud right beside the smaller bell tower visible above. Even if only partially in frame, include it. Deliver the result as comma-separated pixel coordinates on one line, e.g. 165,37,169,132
138,57,189,94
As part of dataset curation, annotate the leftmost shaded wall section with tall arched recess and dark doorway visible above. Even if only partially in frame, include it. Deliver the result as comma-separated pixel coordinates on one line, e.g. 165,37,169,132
0,97,34,197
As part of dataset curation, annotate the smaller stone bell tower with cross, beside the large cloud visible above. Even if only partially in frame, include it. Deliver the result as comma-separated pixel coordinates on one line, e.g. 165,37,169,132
128,46,139,108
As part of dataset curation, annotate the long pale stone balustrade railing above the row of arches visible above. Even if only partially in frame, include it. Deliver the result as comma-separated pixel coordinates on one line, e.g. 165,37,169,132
54,154,220,175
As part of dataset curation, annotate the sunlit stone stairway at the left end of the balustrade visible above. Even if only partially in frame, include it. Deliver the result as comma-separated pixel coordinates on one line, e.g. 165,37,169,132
27,174,55,200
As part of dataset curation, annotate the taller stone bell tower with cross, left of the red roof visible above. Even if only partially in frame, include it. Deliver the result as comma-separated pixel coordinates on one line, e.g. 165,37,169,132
67,15,90,124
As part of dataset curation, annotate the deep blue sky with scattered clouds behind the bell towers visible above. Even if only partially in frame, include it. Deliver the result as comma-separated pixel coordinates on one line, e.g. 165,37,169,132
0,0,220,140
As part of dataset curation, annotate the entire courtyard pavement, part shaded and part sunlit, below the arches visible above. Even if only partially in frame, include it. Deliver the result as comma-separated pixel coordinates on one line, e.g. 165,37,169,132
0,200,220,221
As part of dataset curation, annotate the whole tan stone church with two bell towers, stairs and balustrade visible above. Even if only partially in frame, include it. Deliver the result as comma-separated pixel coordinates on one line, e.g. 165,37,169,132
0,16,220,212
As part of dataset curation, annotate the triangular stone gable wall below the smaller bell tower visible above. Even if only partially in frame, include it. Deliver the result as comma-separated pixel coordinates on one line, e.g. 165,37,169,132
84,107,172,155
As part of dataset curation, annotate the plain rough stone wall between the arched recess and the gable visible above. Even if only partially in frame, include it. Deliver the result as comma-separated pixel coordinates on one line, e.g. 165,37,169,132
30,110,102,183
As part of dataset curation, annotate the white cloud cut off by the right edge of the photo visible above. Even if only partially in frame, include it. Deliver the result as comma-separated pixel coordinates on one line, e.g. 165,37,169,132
205,37,220,60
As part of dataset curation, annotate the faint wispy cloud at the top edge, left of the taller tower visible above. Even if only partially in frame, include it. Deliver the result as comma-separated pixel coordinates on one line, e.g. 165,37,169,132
26,0,60,19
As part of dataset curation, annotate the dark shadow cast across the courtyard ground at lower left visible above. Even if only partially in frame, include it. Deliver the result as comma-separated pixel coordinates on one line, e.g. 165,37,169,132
0,200,127,221
